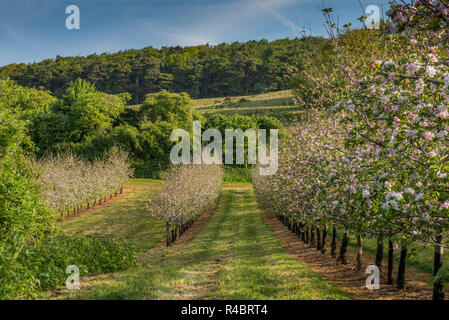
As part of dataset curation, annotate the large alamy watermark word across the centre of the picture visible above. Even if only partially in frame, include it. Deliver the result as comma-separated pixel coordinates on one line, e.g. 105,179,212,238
170,121,279,176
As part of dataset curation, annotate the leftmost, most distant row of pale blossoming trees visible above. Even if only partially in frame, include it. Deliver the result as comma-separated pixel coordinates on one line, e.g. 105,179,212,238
37,151,132,216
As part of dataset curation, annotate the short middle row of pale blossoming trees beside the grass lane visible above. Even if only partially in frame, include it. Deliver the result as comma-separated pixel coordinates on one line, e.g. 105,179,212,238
147,164,223,247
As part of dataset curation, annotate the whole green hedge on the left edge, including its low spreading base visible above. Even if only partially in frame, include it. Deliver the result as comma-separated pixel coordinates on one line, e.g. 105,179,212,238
0,104,137,299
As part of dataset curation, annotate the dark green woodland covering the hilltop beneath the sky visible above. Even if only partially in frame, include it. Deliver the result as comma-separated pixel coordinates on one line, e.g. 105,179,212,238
0,38,327,104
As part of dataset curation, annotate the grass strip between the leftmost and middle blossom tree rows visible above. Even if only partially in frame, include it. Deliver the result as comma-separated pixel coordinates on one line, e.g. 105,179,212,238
62,179,165,252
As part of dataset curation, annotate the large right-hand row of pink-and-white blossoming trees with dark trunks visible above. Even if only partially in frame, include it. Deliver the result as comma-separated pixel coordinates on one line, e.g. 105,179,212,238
256,0,449,299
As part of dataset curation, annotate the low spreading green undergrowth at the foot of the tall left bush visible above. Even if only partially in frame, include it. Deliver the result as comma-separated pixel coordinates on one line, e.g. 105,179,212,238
0,233,137,299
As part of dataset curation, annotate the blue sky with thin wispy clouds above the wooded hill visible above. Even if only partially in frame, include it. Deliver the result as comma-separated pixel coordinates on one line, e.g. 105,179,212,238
0,0,388,66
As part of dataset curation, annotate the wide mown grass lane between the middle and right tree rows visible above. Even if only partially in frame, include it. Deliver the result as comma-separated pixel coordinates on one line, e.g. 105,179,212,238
58,185,349,300
